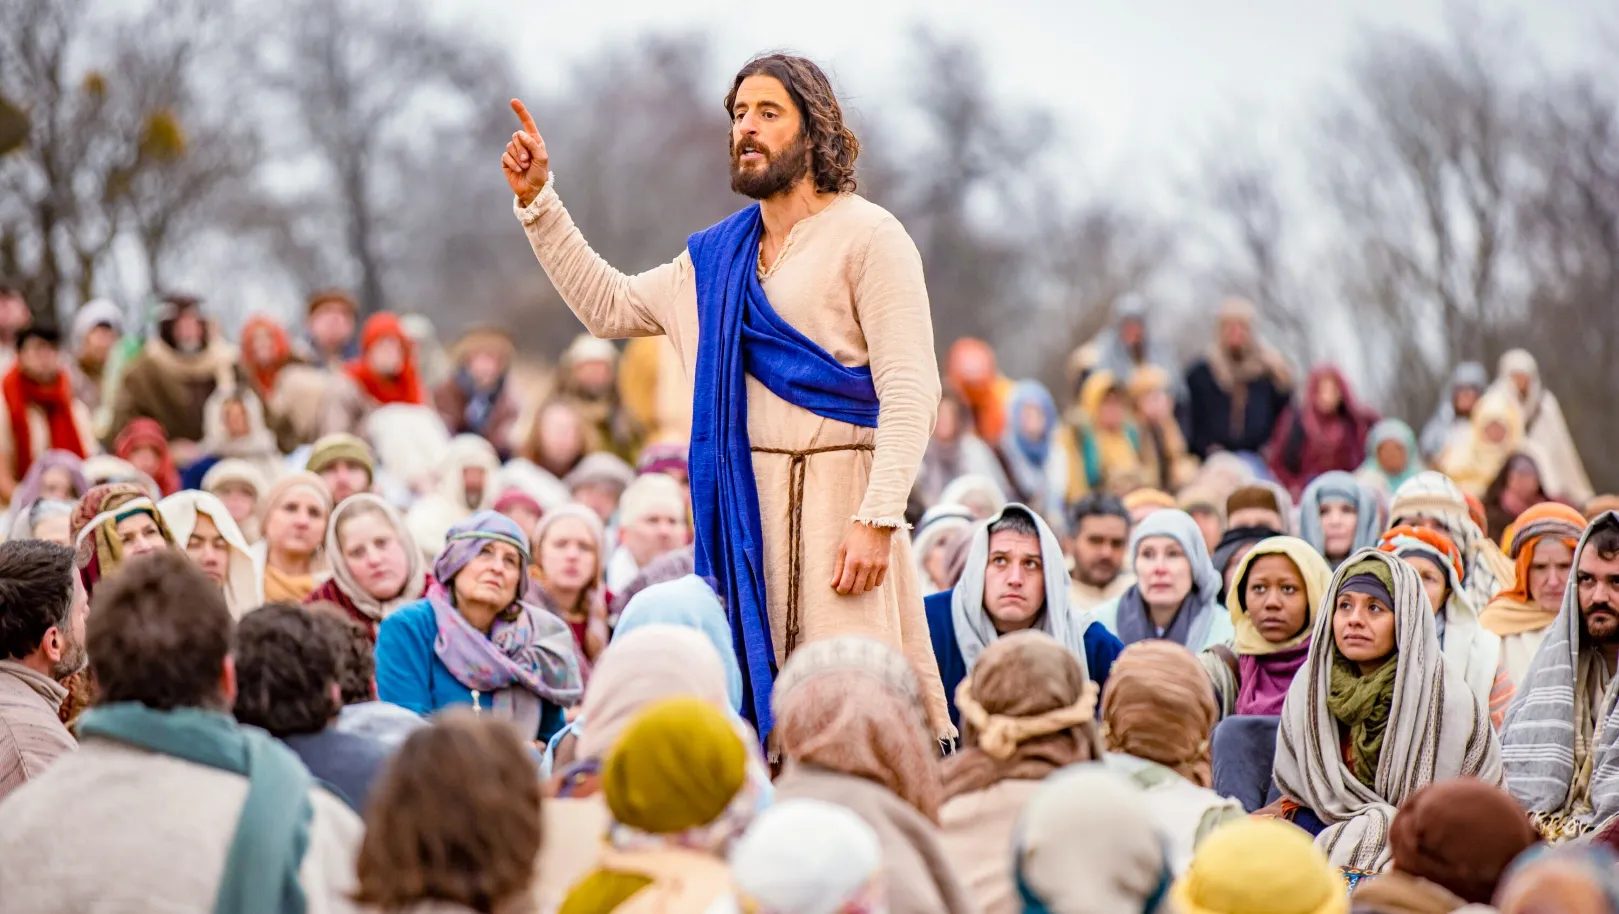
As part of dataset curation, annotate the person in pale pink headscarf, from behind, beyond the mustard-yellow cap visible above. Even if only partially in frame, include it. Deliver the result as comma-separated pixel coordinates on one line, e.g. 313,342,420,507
539,624,741,901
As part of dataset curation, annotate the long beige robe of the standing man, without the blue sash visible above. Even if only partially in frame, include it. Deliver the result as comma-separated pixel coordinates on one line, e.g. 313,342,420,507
516,183,954,736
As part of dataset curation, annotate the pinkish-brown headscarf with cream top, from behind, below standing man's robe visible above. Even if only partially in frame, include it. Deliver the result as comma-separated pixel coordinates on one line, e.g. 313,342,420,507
771,636,944,822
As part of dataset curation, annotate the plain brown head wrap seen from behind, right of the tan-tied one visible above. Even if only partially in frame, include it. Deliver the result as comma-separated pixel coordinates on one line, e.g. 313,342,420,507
1103,641,1219,788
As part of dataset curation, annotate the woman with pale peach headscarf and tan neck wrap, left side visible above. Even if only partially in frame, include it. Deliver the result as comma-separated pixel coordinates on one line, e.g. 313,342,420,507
253,471,332,603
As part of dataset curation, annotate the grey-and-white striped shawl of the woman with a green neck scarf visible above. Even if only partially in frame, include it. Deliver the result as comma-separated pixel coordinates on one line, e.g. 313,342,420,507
1274,550,1502,872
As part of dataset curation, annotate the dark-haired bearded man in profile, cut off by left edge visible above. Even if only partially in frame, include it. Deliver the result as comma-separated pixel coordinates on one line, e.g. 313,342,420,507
0,540,89,801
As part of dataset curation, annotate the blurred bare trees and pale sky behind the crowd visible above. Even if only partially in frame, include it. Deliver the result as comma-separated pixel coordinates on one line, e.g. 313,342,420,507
0,0,1619,490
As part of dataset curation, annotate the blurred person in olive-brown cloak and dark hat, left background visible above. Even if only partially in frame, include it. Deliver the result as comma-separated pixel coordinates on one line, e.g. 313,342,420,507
112,294,240,466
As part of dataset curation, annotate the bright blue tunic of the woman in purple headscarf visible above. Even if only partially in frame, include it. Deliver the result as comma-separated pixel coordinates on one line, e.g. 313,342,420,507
376,599,563,741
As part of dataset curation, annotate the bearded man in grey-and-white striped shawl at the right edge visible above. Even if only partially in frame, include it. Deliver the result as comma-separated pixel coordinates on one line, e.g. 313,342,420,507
1501,511,1619,841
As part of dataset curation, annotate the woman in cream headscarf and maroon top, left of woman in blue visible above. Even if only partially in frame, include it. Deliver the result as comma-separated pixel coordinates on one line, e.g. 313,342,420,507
304,492,427,639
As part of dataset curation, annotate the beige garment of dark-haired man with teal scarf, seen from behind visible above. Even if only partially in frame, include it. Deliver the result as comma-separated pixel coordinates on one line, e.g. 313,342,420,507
0,739,364,914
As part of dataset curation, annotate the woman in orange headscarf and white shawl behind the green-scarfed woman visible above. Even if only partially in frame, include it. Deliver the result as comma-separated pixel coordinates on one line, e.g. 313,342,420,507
1379,527,1515,730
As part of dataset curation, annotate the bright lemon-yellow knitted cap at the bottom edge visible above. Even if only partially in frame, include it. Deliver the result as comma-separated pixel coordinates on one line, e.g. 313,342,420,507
1169,819,1349,914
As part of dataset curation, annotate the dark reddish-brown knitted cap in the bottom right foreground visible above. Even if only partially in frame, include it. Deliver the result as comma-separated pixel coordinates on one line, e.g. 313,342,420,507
1389,778,1540,904
